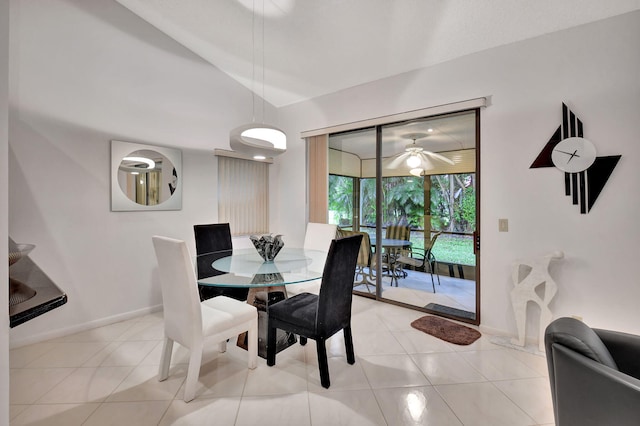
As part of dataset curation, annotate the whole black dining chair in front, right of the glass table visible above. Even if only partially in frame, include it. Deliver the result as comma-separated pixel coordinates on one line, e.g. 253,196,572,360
267,235,362,388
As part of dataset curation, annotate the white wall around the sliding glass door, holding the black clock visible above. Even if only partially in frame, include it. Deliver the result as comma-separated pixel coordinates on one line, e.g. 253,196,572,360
280,12,640,336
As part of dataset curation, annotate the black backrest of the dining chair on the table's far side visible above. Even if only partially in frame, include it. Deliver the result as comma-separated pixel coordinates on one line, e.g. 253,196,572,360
193,223,233,279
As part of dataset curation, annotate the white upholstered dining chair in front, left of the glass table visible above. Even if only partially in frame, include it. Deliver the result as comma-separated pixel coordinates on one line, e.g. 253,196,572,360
152,236,258,402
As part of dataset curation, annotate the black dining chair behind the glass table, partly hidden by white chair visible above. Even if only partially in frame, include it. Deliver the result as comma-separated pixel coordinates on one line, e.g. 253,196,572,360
193,223,249,301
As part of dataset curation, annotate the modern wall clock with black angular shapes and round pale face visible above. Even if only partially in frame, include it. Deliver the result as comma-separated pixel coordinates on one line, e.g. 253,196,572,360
530,103,622,214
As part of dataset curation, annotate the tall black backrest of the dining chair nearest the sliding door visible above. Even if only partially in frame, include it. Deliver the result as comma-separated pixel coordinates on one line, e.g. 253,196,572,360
316,235,362,335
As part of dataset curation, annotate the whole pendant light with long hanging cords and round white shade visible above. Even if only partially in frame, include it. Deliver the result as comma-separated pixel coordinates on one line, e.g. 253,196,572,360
229,0,287,160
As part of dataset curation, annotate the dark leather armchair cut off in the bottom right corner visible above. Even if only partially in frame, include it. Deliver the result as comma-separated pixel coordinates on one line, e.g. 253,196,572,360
544,318,640,426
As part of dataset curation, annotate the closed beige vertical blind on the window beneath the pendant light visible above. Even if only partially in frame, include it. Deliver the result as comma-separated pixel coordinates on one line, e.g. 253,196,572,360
218,157,269,235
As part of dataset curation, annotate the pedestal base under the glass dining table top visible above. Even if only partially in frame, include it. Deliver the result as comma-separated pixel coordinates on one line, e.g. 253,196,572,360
237,286,298,359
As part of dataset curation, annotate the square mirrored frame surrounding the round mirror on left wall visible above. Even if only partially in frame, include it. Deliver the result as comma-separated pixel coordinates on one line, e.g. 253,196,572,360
111,140,183,212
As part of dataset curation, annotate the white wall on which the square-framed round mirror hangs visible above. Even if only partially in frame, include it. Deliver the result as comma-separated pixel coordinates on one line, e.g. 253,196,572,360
3,0,277,346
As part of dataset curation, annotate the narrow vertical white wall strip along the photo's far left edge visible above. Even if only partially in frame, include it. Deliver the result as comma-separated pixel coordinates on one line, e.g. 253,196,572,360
0,0,9,425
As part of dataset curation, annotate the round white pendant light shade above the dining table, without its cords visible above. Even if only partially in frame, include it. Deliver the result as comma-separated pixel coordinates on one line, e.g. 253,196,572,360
229,123,287,158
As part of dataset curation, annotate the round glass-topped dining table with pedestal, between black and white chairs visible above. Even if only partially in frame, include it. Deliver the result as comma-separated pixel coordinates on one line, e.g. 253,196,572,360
195,247,327,358
